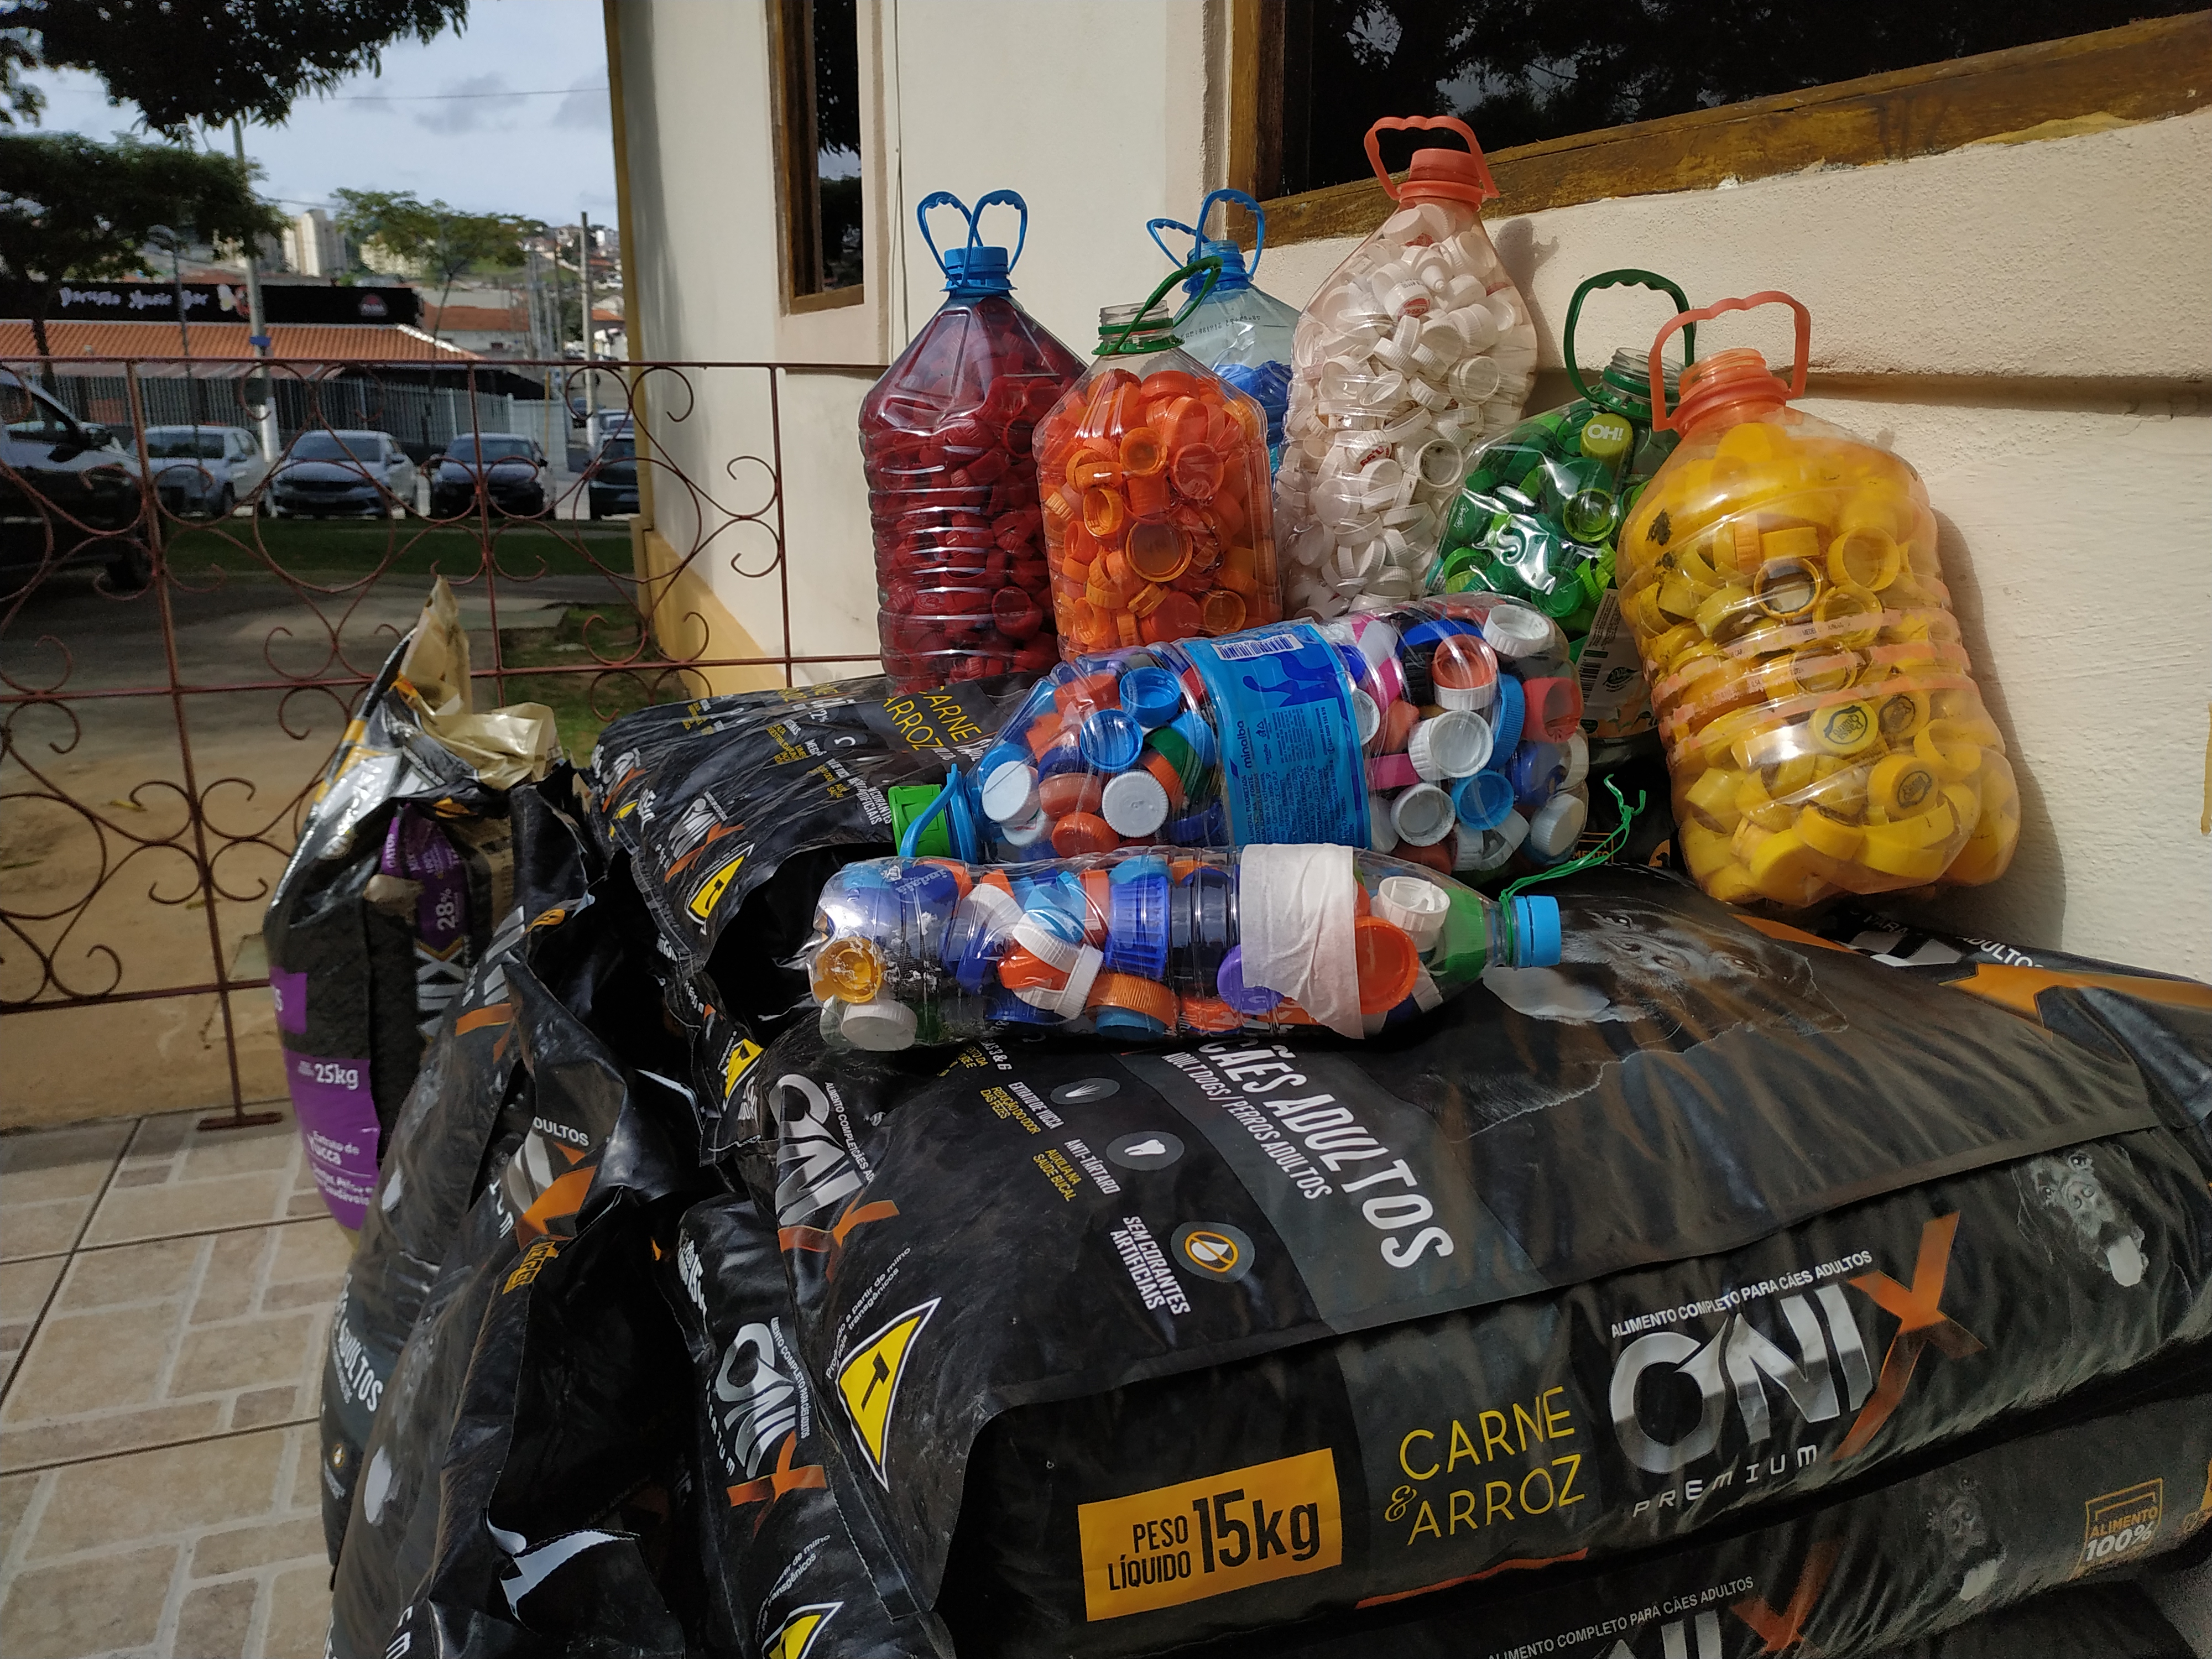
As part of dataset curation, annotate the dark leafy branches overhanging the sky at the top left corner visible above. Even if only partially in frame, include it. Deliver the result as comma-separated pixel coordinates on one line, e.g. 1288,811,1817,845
0,0,469,139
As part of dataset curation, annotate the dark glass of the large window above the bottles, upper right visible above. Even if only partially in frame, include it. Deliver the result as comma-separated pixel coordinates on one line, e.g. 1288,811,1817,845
1256,0,2203,197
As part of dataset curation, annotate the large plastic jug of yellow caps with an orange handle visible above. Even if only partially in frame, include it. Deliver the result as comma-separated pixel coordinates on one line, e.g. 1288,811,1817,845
1619,292,2020,909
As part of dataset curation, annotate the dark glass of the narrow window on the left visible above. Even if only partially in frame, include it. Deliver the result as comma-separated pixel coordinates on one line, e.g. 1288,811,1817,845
776,0,863,294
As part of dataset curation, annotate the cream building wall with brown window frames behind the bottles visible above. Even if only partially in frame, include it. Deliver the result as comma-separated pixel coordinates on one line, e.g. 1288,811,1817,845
608,0,2212,975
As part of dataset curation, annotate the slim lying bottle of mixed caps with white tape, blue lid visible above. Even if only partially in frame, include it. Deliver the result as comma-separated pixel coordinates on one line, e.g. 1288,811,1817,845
803,845,1559,1051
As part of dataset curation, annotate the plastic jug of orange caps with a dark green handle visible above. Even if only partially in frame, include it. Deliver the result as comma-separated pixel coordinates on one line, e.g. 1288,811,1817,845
1035,259,1283,659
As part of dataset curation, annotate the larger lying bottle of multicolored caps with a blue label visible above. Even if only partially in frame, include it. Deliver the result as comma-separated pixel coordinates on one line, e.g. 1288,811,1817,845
902,593,1588,878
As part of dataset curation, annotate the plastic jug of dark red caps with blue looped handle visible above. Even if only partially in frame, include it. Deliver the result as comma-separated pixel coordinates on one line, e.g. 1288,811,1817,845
860,190,1082,690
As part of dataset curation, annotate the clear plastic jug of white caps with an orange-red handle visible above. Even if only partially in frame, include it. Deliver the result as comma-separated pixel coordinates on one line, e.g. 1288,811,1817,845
1274,115,1535,617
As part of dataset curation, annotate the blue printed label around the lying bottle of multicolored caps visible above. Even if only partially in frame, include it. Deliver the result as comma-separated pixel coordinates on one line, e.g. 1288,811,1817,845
1181,622,1367,847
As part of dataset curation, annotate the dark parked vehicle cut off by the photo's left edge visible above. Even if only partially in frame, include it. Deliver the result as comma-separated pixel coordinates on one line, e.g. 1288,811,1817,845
0,369,153,593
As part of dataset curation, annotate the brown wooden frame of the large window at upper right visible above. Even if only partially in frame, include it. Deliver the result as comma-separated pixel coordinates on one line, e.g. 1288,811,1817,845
1228,0,2212,246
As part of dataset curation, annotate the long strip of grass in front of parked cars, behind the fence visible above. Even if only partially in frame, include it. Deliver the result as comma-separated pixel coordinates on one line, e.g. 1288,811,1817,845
168,518,630,586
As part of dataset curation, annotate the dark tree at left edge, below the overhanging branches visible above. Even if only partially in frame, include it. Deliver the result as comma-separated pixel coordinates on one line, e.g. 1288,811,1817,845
0,133,283,369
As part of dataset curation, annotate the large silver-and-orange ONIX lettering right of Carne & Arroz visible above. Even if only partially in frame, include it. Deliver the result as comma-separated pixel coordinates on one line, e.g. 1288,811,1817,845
1608,1214,1982,1475
